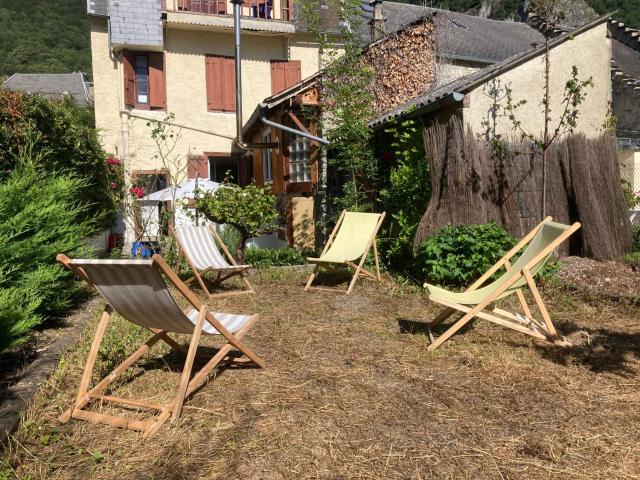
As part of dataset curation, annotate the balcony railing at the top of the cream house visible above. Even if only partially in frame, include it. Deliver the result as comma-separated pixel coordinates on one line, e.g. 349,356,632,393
162,0,293,22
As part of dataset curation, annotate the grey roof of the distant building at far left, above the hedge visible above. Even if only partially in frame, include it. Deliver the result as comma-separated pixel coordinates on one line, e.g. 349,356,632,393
2,72,91,106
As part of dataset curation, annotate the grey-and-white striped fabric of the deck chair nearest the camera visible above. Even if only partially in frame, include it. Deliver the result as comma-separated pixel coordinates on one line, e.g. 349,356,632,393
71,260,251,335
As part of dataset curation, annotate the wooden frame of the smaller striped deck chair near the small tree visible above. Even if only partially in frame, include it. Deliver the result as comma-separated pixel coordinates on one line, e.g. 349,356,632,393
169,225,256,298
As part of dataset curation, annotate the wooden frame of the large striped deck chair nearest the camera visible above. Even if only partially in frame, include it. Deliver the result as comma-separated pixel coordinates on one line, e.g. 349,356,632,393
57,254,266,437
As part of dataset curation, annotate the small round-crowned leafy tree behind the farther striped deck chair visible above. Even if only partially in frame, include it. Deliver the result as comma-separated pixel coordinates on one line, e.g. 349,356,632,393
195,183,278,262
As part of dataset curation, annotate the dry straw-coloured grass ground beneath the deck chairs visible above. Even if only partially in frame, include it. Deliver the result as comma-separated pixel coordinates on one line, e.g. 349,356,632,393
0,271,640,479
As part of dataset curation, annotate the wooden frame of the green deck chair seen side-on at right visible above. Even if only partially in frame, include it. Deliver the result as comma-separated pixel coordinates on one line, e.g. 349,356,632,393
427,217,580,351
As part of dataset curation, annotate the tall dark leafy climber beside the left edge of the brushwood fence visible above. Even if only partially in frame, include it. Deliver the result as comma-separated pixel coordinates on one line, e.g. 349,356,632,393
380,120,431,268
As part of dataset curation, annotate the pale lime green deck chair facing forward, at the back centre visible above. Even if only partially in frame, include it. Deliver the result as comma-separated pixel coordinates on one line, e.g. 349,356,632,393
304,210,385,295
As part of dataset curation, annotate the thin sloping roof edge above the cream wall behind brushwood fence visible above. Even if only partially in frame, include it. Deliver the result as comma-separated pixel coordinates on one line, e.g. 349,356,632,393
369,15,609,128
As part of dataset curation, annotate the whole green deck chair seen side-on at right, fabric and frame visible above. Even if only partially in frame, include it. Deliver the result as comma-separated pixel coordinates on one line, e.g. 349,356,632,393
424,217,580,350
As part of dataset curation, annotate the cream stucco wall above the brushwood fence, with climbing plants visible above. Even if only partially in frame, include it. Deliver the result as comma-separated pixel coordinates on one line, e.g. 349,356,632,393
463,23,611,136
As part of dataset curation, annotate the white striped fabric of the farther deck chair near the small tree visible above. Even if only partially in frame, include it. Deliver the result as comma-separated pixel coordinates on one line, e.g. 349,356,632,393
175,227,251,270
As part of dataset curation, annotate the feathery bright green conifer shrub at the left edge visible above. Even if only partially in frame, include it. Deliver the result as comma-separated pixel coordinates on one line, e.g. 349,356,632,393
0,162,95,351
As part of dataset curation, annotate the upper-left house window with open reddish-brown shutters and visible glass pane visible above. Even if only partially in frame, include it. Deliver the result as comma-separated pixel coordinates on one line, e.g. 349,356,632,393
123,52,167,110
